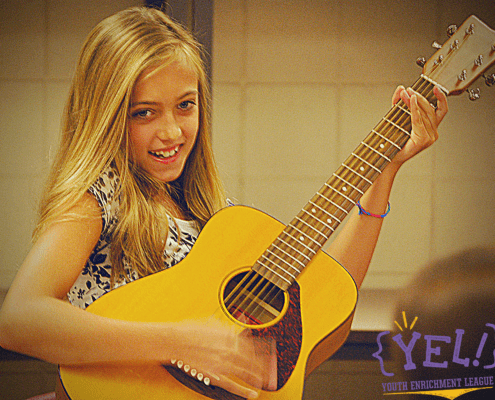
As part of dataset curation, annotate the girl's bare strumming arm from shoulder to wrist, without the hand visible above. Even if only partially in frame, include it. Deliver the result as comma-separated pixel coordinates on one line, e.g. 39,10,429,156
0,195,172,364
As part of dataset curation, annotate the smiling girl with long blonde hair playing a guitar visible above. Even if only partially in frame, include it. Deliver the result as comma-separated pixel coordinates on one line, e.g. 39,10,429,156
0,3,447,398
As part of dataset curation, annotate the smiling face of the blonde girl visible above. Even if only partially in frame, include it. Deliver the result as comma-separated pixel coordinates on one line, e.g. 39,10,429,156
129,62,199,182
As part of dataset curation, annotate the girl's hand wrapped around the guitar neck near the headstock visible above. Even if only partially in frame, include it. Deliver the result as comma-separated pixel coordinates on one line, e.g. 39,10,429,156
392,86,448,165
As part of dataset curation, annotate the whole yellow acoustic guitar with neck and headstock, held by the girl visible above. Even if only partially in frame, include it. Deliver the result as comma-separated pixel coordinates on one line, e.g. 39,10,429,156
60,16,495,400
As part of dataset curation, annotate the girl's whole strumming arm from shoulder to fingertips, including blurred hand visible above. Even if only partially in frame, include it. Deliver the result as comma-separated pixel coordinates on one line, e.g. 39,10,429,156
0,194,263,397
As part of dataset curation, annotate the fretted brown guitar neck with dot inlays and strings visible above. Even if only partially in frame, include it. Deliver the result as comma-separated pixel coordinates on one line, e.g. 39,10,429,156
253,76,436,290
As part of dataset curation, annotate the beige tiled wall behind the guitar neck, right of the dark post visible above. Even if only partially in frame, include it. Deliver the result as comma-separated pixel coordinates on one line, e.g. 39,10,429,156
213,0,495,329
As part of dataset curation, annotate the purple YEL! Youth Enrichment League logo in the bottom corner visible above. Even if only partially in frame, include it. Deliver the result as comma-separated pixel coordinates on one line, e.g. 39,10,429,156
373,312,495,400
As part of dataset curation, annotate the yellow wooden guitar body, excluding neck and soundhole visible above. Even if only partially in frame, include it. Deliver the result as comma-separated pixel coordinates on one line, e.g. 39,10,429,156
60,206,357,400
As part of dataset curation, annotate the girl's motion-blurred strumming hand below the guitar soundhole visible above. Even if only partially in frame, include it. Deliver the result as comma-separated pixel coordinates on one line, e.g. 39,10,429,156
170,321,277,399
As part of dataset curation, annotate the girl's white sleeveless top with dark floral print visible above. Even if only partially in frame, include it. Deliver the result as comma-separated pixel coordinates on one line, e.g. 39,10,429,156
67,167,199,309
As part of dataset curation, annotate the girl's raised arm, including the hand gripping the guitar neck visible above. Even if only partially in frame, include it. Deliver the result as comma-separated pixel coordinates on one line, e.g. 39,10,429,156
328,86,448,288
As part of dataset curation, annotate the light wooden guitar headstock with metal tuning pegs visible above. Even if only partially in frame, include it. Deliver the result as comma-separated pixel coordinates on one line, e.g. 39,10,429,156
418,15,495,100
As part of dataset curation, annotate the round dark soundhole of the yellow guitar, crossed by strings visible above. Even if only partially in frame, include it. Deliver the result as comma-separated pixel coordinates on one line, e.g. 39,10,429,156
223,271,285,325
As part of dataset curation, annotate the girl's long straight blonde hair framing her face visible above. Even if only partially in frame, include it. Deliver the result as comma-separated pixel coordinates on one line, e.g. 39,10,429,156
34,7,225,282
